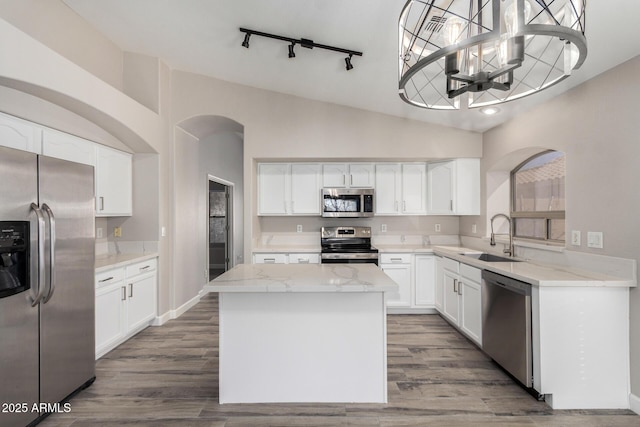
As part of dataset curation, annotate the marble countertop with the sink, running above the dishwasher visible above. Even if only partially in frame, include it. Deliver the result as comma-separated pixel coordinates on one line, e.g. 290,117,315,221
434,246,637,288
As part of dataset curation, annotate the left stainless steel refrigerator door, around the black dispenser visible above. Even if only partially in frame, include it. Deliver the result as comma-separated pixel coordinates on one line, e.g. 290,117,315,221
0,147,38,427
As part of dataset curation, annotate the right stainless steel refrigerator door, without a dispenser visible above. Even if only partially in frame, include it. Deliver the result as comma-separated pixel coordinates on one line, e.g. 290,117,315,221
39,156,95,403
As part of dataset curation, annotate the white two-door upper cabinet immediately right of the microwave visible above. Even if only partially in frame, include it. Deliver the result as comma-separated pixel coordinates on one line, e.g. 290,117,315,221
375,163,427,215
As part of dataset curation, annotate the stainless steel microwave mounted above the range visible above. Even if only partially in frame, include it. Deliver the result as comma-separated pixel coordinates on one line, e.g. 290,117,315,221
322,188,374,218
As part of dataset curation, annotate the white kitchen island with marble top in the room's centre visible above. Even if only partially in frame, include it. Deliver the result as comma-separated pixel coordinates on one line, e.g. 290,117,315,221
205,264,398,403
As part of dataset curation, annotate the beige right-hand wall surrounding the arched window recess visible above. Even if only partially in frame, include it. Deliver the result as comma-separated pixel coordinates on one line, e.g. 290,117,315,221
460,57,640,396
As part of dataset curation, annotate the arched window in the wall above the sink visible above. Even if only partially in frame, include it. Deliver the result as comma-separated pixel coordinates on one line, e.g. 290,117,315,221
511,151,565,243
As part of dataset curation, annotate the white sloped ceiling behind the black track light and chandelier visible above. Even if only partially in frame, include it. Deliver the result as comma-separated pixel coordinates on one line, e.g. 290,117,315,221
63,0,640,132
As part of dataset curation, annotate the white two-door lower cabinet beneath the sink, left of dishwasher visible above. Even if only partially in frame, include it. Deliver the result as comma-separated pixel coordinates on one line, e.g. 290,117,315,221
436,258,482,346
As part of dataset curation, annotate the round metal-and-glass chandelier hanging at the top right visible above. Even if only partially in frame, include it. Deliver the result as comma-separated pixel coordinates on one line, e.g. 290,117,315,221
399,0,587,110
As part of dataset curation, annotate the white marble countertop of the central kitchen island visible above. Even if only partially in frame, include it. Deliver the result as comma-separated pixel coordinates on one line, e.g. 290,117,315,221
204,264,398,292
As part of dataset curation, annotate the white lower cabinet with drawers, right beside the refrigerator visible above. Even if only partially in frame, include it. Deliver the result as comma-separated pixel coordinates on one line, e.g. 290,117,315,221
96,258,157,359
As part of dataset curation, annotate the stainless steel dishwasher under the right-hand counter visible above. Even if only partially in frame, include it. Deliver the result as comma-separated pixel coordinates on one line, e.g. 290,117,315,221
482,270,533,388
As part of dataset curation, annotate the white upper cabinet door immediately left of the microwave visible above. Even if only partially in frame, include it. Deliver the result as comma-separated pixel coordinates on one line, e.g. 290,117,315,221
291,163,321,215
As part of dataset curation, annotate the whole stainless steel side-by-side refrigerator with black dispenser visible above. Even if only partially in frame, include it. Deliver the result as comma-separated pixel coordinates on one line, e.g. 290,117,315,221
0,147,95,427
